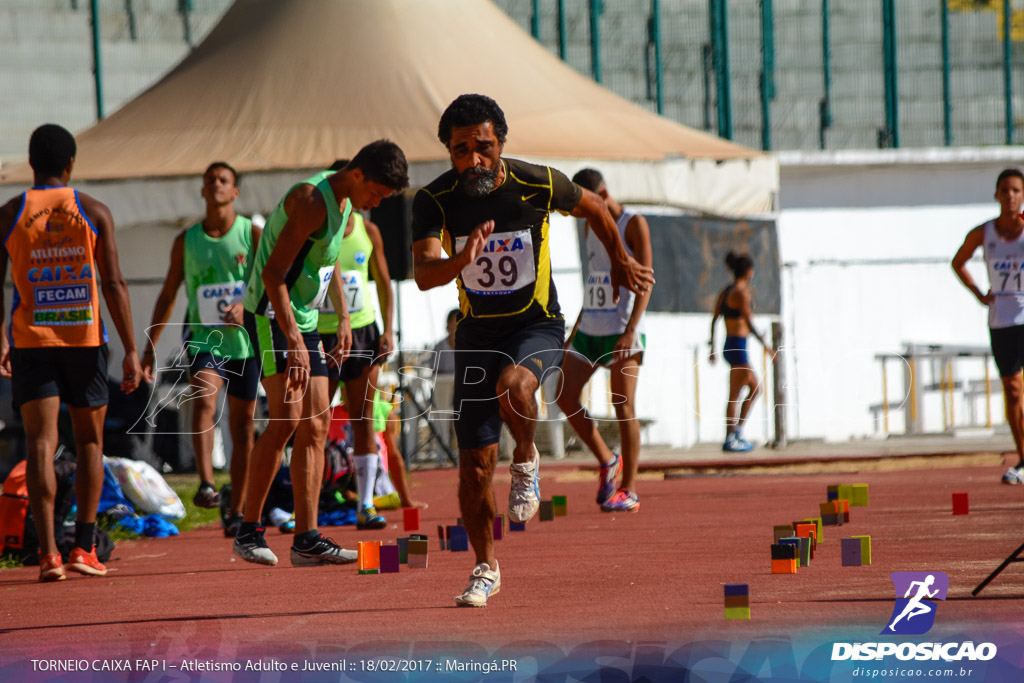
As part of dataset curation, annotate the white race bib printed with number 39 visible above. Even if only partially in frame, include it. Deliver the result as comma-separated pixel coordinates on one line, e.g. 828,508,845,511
456,230,537,295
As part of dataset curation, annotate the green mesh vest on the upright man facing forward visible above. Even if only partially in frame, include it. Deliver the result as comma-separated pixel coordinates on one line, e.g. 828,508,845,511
183,216,253,358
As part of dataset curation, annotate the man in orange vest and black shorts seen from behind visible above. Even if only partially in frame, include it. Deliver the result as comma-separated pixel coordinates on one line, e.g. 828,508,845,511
0,124,142,582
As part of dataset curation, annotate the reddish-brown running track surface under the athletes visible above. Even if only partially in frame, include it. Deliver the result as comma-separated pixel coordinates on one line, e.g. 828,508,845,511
0,458,1024,664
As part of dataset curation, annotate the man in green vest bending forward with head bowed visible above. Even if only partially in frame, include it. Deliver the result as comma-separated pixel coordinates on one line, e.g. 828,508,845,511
233,140,409,566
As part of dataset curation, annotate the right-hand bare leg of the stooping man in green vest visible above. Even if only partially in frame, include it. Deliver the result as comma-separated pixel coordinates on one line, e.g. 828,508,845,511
291,376,331,535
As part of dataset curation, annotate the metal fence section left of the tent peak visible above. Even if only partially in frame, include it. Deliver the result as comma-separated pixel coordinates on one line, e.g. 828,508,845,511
0,0,232,161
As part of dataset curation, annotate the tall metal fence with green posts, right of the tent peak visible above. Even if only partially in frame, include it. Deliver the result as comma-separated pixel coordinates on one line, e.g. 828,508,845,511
498,0,1024,150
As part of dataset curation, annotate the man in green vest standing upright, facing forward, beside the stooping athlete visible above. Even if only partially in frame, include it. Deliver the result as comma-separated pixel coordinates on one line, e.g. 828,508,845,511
142,162,260,537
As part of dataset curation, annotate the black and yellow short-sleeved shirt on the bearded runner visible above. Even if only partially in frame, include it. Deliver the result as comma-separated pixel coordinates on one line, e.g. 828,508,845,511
413,159,583,334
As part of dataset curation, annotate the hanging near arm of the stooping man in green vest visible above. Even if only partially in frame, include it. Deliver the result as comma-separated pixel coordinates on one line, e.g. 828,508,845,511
260,183,325,389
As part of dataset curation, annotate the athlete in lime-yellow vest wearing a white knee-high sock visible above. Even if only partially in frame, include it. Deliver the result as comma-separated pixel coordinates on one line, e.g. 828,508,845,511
317,159,397,529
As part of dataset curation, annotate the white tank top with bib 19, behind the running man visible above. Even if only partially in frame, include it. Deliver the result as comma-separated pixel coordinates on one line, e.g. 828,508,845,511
580,211,644,337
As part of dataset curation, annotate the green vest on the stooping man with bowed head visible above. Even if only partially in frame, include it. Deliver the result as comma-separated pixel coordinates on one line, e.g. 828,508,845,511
244,171,352,333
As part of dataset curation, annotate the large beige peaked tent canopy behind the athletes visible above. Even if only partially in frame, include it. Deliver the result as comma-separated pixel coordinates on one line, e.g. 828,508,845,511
0,0,777,219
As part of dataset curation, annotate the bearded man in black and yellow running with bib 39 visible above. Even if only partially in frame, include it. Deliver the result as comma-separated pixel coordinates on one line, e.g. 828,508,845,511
413,95,654,607
